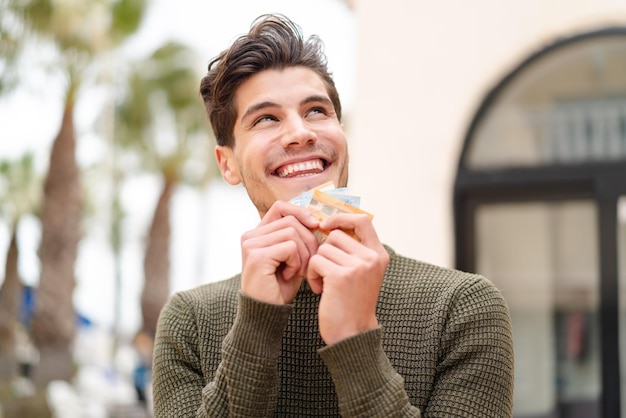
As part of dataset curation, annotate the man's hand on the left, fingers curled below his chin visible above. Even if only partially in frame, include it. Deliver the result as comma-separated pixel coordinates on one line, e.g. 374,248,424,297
241,201,319,305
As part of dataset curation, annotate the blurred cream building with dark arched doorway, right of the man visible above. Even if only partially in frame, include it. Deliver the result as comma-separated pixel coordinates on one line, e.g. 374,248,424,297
350,0,626,418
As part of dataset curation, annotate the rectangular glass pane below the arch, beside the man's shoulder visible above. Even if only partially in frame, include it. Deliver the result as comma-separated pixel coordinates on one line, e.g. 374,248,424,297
476,201,601,418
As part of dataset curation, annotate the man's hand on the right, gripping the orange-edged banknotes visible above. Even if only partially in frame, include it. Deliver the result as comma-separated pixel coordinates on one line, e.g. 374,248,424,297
307,213,389,345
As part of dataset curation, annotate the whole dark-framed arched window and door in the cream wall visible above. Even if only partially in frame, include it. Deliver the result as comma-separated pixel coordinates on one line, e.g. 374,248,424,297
454,28,626,418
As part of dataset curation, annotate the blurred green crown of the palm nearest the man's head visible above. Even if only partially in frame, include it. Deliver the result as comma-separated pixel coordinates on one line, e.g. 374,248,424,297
115,42,216,184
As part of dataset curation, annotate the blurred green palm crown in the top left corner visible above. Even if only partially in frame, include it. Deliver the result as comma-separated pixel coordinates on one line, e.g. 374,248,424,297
0,0,146,97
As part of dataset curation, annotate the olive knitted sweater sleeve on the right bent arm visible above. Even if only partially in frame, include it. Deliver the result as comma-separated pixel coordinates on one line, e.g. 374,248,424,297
320,277,513,418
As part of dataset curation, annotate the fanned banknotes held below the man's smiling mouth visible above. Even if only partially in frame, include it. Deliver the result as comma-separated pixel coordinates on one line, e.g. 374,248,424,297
291,182,374,244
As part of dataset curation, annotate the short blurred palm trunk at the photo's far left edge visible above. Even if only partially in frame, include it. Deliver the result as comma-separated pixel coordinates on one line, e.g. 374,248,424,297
0,227,22,382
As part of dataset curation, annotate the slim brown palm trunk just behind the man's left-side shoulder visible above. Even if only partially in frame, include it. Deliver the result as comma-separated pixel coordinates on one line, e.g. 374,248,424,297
141,178,174,338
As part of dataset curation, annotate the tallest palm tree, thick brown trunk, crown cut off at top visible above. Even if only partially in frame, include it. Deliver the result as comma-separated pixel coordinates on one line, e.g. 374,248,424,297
3,0,145,386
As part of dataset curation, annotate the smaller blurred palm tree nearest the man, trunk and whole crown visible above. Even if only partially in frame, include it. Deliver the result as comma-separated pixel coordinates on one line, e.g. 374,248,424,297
116,42,217,336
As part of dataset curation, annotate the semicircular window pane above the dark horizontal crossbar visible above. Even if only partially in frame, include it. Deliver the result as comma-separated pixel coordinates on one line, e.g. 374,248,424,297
465,34,626,170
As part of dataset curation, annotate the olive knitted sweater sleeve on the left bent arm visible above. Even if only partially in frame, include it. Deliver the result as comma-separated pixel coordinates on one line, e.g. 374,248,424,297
153,294,292,418
